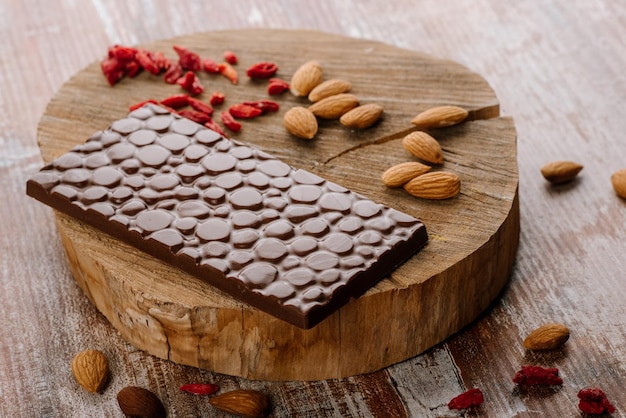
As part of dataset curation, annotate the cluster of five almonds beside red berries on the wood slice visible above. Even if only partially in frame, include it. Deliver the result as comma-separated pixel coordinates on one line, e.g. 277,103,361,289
283,61,383,139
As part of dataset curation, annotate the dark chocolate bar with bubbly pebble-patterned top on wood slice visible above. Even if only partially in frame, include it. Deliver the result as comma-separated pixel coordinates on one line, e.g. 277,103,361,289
27,104,428,328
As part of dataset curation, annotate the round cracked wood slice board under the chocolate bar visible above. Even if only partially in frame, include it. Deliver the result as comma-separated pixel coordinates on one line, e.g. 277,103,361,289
38,30,519,380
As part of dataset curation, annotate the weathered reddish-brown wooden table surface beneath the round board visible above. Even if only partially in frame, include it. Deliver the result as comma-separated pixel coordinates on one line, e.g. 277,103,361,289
0,0,626,417
